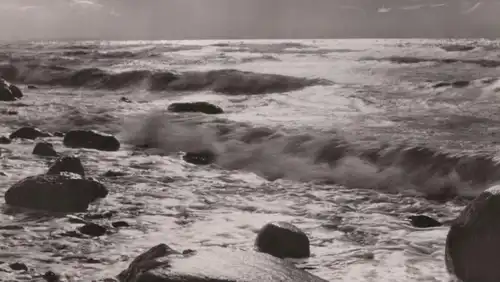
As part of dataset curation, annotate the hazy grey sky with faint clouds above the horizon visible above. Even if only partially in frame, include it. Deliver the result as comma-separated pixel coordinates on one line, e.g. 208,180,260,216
0,0,500,40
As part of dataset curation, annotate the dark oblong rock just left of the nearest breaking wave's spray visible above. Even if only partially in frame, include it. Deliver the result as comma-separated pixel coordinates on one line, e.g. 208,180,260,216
63,130,120,151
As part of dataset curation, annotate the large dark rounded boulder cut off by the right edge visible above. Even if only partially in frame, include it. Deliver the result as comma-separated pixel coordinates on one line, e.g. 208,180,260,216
446,185,500,282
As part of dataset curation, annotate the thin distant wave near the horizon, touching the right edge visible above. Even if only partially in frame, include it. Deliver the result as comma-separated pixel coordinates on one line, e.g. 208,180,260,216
362,56,500,68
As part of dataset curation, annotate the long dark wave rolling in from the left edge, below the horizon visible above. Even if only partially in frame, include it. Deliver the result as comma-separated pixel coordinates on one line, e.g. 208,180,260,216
0,64,331,95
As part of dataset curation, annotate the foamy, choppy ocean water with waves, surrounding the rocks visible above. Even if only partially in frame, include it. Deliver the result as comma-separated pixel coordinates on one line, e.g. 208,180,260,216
0,39,500,282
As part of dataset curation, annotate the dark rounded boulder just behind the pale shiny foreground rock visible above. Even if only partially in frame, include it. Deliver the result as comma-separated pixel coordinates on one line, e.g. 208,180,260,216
255,222,311,258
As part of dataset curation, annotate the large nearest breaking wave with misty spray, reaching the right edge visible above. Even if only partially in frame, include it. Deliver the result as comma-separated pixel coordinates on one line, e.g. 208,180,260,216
125,112,500,201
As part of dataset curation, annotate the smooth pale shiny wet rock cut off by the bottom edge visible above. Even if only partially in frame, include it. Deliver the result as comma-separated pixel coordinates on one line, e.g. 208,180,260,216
118,244,327,282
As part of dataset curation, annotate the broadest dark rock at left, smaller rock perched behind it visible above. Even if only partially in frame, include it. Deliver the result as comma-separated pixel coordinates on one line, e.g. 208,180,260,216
4,173,108,212
